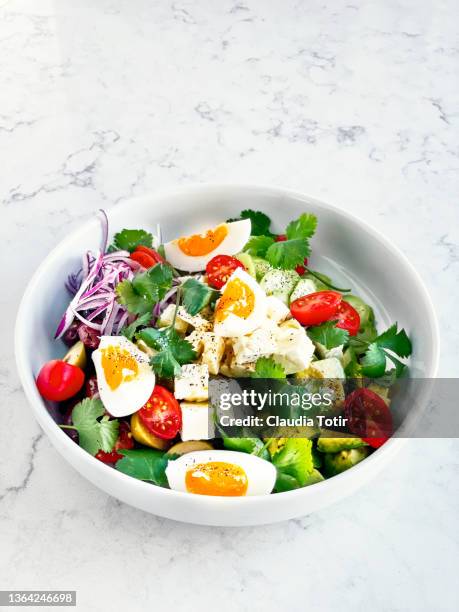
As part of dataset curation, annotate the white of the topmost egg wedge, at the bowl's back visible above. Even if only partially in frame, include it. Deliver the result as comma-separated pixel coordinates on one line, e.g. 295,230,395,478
164,219,252,272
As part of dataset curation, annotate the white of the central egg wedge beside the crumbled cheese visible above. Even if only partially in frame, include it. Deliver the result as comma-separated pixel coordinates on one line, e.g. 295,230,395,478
214,268,268,338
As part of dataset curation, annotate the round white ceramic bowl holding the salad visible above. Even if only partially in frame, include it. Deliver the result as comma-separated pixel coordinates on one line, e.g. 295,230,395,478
16,185,439,526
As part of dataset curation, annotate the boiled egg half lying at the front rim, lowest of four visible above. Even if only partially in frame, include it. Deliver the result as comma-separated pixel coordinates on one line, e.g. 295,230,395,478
166,450,276,497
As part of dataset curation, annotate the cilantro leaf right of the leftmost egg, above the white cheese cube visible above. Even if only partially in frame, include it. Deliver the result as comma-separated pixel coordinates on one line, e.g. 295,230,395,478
136,327,196,378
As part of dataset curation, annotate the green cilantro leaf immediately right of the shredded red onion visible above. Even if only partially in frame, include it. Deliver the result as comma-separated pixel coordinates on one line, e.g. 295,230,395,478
116,263,172,315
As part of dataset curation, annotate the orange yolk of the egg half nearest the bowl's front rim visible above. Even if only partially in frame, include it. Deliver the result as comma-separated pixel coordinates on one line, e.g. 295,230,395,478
185,461,249,497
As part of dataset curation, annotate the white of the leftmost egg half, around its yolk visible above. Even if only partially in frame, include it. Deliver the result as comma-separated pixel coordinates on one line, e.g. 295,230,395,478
92,336,156,417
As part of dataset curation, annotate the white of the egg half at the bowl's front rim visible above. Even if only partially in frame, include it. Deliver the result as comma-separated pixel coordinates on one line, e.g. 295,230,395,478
166,450,276,496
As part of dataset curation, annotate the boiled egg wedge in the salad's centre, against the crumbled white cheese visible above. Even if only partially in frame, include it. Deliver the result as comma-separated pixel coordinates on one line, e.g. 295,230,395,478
214,268,267,338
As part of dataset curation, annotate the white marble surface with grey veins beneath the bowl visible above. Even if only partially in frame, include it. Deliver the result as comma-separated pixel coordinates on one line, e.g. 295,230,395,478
0,0,459,612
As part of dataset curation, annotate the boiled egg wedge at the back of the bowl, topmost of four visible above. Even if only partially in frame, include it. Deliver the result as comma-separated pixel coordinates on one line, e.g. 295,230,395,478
164,219,251,272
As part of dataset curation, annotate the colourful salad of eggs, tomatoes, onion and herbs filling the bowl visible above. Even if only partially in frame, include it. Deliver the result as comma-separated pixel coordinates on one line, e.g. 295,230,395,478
36,209,412,497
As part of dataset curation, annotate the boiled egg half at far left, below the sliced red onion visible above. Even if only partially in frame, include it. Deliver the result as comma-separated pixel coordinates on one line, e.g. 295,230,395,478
92,336,155,417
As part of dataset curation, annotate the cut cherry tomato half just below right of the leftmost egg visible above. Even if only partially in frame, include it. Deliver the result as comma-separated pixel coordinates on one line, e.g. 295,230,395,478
138,385,182,440
